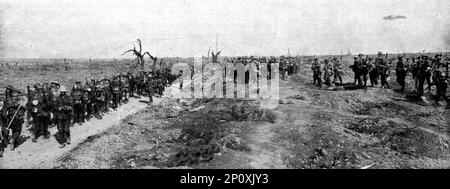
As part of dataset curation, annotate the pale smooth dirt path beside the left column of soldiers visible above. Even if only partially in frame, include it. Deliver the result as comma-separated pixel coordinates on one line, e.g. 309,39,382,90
0,98,155,169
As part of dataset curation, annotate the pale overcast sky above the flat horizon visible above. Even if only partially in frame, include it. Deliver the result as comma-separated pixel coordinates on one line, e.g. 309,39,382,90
0,0,450,58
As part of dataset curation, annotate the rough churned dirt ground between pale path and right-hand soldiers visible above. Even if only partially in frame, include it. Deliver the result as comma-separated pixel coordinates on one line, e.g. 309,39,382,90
54,60,450,169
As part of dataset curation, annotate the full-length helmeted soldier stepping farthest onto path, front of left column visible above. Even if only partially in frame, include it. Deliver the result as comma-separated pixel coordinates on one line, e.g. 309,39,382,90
55,86,73,148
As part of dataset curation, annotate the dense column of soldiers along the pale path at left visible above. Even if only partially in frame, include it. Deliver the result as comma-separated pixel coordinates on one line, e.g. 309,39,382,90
0,69,176,157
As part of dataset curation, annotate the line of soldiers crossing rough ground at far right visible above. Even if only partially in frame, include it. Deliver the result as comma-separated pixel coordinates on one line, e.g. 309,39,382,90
311,52,450,108
